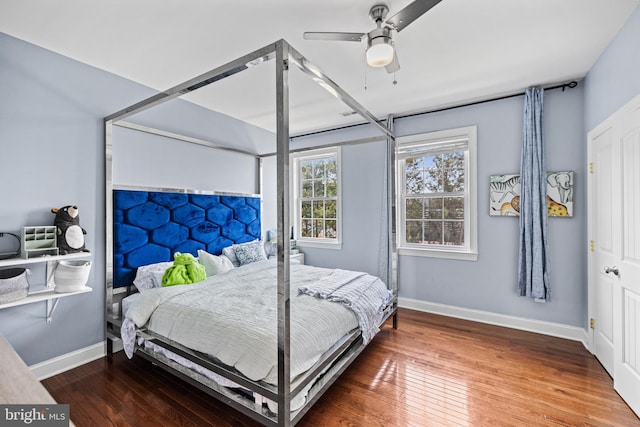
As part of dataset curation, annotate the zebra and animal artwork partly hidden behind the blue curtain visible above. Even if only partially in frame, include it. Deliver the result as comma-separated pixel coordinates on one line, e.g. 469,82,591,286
489,172,573,217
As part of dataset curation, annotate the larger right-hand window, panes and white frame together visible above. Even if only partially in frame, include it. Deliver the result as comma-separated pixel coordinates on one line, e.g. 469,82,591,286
396,126,477,260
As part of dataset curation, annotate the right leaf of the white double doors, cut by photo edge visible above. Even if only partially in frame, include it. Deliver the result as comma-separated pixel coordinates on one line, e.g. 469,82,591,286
613,99,640,415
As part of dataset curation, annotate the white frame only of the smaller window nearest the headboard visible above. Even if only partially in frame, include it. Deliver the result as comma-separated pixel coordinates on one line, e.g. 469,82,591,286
290,147,342,250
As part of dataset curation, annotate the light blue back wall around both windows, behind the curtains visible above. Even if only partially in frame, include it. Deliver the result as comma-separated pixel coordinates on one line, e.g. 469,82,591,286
292,85,586,326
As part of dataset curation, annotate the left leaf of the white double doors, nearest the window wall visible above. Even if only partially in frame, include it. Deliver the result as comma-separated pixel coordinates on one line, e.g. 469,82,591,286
589,121,619,377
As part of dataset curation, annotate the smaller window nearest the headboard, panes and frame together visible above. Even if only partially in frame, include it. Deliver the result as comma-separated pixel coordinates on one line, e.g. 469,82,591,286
292,147,341,248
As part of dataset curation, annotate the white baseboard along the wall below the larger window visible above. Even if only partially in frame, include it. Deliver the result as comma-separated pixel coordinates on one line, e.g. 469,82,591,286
398,298,589,349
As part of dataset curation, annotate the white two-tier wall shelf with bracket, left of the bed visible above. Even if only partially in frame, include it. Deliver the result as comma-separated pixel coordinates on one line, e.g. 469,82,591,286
0,252,93,323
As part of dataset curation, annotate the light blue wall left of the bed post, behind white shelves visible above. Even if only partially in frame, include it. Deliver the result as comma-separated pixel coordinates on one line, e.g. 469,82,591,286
0,34,146,365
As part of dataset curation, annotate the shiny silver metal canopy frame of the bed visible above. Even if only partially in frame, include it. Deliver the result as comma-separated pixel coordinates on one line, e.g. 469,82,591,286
104,40,396,426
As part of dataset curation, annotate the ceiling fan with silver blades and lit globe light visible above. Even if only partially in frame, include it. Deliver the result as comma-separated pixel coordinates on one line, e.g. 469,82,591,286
303,0,441,73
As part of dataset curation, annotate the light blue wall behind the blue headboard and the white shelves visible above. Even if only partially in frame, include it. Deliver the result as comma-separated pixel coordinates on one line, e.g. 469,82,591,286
0,33,273,365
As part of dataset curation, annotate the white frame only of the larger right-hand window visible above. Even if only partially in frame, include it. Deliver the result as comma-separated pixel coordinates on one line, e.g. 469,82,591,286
396,126,478,261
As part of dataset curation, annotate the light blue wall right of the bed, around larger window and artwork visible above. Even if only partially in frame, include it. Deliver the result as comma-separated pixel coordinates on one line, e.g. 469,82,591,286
395,85,586,326
